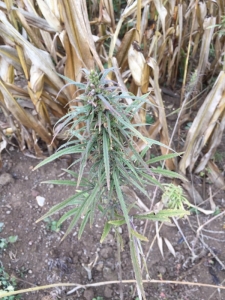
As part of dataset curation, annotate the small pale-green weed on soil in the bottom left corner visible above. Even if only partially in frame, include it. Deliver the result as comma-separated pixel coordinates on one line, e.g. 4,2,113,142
0,263,20,300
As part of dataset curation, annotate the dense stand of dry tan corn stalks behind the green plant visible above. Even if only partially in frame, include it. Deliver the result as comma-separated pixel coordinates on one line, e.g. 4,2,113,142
0,0,225,193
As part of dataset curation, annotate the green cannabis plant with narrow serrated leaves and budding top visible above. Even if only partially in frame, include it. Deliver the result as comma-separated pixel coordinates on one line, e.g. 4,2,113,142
36,69,186,295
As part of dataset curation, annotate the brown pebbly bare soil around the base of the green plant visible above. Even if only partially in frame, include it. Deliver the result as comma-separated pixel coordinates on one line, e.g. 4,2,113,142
0,106,225,300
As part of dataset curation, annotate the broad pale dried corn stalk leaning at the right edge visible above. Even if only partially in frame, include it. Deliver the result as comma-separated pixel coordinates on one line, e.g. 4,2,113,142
179,71,225,174
